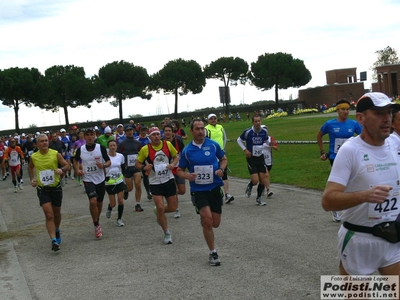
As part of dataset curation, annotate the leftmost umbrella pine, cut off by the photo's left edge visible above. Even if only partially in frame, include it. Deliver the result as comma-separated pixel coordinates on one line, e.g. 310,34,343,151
0,68,43,133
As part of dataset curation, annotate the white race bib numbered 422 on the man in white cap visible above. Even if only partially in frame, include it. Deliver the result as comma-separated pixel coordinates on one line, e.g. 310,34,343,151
368,181,400,222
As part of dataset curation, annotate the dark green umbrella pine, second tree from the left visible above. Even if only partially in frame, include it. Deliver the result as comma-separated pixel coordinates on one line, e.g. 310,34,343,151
39,65,95,127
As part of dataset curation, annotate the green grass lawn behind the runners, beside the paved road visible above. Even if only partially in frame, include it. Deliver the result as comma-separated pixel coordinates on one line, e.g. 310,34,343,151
180,111,354,190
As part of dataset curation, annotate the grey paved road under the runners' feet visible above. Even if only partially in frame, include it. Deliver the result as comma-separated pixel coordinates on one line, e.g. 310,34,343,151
0,168,339,300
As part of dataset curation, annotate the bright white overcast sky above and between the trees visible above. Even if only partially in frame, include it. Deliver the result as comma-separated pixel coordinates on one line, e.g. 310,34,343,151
0,0,400,129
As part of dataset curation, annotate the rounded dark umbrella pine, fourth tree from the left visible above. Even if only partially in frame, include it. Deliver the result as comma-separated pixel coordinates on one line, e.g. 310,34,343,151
151,58,206,119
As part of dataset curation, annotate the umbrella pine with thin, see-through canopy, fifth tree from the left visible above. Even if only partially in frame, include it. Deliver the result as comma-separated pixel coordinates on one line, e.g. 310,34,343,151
204,57,249,115
